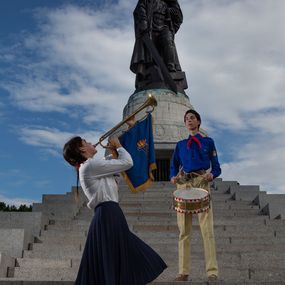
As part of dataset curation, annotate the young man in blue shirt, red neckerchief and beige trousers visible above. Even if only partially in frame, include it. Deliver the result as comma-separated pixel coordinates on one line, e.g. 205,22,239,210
170,110,221,281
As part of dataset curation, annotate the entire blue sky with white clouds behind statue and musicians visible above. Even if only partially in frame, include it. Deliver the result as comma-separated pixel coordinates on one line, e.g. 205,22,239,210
0,0,285,205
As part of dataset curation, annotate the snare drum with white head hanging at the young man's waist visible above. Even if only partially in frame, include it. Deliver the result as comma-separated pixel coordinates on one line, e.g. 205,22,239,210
173,188,210,214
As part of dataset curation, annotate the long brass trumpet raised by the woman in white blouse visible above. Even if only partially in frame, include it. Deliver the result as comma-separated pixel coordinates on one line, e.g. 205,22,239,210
94,94,157,148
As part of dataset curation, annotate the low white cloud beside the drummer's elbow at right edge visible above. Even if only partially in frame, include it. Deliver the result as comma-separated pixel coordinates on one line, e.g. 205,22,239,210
222,136,285,194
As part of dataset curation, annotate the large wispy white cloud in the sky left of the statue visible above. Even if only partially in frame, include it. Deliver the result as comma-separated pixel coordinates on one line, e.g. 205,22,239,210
1,2,134,124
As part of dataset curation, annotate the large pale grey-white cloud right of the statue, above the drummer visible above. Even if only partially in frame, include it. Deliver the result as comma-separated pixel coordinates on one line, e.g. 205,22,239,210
177,0,285,129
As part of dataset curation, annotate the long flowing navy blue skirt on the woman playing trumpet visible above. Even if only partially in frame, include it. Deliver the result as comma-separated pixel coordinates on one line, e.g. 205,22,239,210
75,202,167,285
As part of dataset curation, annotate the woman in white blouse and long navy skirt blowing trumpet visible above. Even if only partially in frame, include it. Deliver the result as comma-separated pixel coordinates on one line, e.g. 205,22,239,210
63,134,166,285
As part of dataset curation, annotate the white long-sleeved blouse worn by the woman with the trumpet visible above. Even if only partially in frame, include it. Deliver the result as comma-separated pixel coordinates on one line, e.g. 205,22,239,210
79,147,133,209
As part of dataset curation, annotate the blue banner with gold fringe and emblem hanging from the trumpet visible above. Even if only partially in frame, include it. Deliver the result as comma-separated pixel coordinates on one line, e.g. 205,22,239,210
120,114,156,192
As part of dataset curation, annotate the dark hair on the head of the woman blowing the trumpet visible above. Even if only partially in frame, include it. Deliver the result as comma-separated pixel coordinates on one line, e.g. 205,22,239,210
63,137,86,167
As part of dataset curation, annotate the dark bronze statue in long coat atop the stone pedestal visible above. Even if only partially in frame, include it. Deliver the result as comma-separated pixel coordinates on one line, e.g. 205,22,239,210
130,0,187,92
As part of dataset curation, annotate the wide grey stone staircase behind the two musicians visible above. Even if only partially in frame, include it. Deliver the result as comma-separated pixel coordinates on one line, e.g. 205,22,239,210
0,179,285,285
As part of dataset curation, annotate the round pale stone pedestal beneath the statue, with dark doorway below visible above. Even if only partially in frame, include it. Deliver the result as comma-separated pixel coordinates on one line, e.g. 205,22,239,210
123,89,194,181
